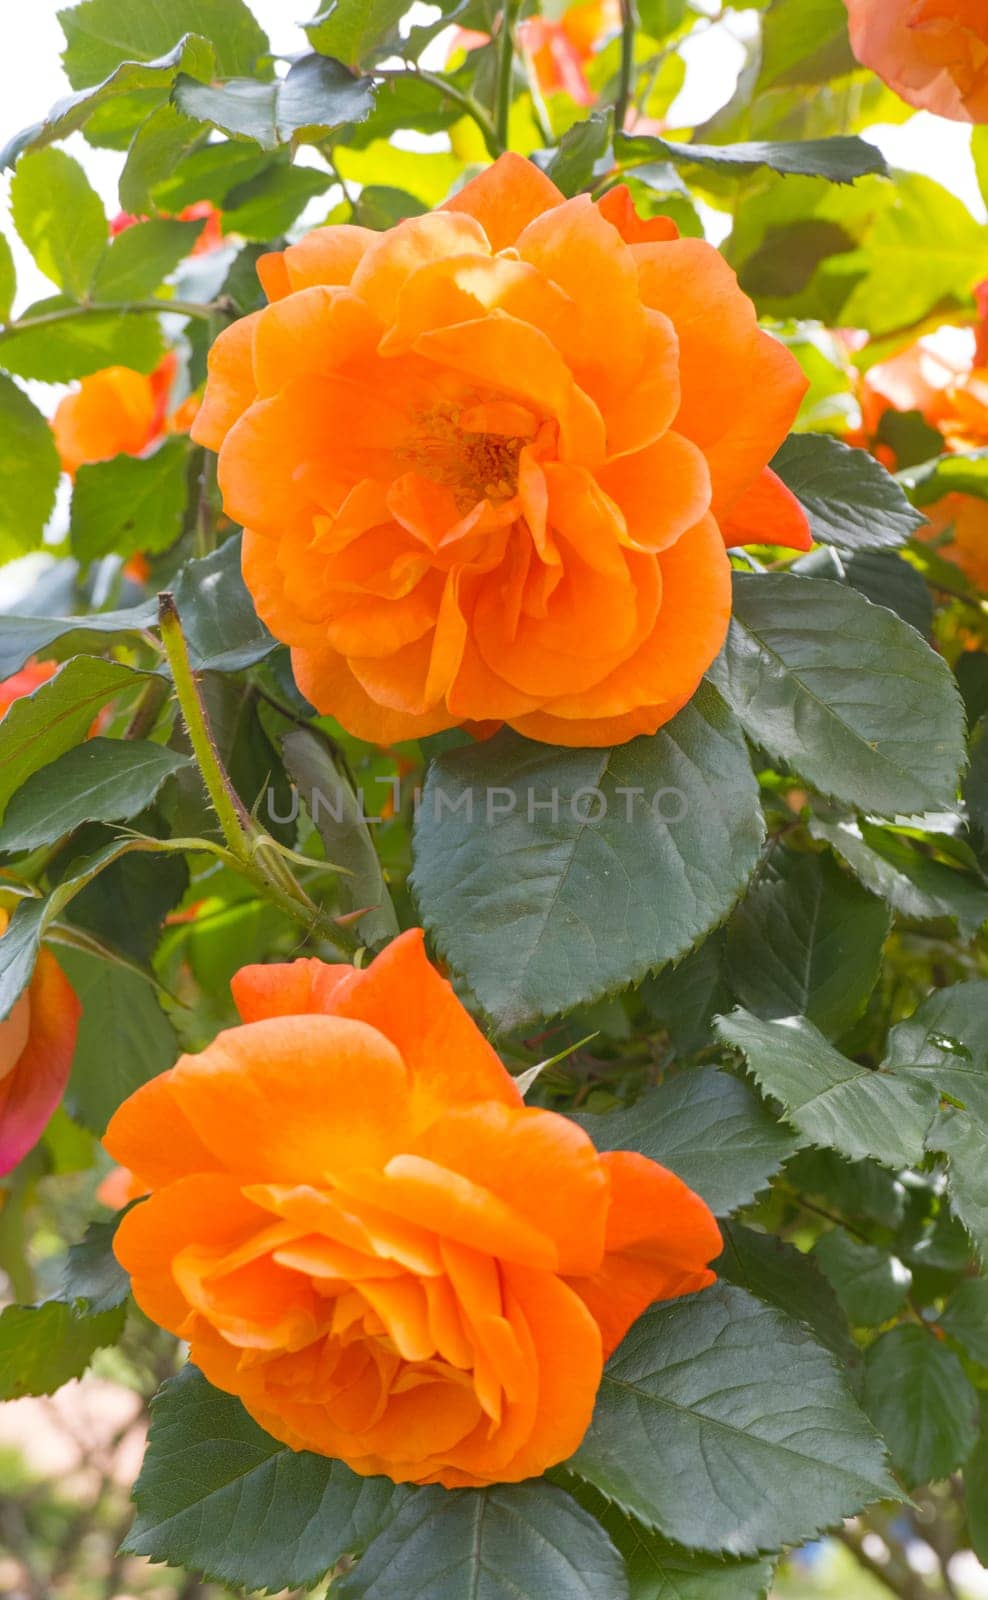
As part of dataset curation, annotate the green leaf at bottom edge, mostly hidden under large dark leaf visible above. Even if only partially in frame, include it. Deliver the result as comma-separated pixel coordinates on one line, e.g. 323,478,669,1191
595,1496,772,1600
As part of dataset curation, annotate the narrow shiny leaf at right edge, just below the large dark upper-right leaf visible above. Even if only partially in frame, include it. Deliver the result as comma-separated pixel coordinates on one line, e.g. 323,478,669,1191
809,816,988,939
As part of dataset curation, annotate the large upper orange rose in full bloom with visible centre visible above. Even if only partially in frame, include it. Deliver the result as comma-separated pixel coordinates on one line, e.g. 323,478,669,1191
192,155,809,746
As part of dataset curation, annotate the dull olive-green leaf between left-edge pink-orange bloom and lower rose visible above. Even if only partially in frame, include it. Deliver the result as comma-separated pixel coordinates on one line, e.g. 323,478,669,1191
59,949,179,1136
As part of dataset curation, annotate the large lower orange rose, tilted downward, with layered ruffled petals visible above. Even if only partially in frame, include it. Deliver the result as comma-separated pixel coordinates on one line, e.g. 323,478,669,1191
106,930,721,1488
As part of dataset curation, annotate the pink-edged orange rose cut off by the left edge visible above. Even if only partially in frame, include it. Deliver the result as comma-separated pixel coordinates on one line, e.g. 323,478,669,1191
0,910,80,1176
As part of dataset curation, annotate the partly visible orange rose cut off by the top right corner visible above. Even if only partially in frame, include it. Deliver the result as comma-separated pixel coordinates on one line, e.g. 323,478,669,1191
844,0,988,122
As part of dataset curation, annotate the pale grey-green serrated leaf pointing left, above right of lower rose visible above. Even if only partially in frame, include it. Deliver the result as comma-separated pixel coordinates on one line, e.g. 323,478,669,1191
718,1010,937,1166
